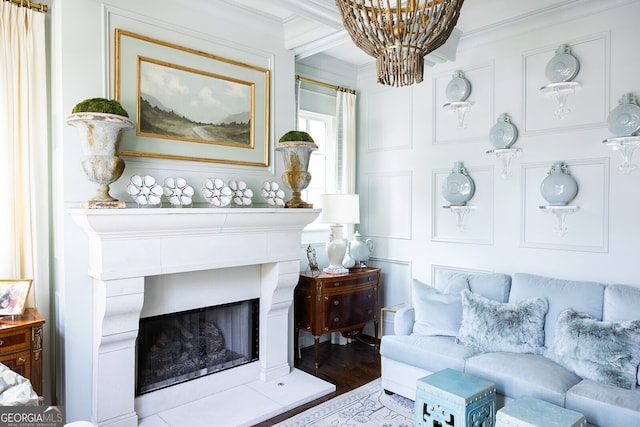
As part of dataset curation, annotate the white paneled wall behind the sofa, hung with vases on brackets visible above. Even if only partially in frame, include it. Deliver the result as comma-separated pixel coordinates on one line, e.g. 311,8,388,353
358,1,640,332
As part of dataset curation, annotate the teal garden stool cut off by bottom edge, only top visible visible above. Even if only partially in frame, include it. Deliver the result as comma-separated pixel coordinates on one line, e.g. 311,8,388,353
496,396,587,427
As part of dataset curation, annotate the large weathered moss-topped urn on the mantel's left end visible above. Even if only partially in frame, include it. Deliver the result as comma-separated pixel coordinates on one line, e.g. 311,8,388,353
67,98,134,209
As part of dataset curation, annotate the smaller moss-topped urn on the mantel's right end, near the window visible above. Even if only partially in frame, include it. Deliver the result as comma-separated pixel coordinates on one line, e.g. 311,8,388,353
276,130,318,208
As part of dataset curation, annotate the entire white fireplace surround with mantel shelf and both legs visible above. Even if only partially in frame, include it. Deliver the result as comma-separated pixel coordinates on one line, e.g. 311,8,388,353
68,208,320,427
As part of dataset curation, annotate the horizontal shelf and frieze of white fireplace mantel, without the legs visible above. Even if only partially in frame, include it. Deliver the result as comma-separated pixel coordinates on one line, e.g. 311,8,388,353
68,208,320,280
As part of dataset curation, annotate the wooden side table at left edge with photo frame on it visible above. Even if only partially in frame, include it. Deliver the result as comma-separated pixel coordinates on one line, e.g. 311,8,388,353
0,308,45,396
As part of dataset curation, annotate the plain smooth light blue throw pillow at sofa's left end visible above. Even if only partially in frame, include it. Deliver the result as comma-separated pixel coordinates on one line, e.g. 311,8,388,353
412,279,462,337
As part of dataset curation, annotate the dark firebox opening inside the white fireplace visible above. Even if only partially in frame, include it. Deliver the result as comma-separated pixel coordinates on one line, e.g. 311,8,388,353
136,299,259,395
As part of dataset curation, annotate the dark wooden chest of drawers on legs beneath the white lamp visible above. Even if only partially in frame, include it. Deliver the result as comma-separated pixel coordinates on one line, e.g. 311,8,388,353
294,268,380,368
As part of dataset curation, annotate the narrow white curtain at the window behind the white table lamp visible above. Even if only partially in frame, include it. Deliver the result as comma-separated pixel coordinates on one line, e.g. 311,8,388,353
336,89,356,193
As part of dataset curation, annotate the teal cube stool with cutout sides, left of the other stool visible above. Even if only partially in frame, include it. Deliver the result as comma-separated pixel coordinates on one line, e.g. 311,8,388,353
415,369,496,427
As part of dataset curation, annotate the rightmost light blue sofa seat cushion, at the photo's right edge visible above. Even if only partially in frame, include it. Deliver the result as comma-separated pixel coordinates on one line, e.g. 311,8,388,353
565,380,640,427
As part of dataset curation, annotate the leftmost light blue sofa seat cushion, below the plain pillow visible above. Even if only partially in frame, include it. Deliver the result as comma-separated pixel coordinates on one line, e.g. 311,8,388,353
380,334,476,372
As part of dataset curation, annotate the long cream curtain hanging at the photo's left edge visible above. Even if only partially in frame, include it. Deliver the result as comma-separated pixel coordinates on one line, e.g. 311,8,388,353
0,1,49,306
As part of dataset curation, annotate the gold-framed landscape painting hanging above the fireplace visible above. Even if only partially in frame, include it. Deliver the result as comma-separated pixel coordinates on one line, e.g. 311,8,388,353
114,28,270,166
